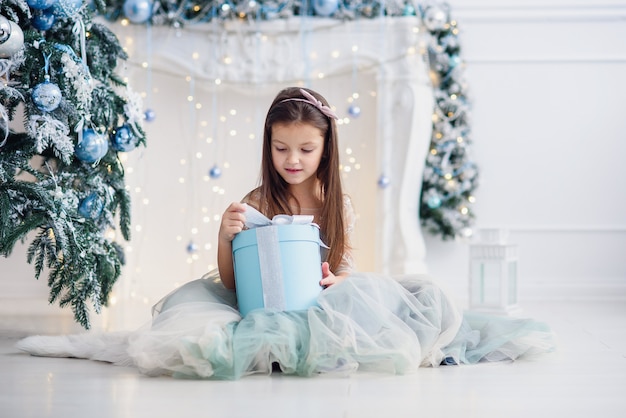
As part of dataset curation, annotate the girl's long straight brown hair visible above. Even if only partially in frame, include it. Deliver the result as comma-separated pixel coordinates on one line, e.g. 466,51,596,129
258,87,347,270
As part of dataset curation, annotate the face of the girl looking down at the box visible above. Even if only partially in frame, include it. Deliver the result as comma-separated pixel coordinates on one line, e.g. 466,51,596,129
271,123,324,186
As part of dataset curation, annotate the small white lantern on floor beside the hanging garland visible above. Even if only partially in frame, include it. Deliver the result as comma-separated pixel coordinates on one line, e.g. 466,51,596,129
469,229,520,315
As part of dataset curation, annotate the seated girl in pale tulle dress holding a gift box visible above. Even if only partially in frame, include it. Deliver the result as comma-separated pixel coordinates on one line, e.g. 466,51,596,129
18,88,553,379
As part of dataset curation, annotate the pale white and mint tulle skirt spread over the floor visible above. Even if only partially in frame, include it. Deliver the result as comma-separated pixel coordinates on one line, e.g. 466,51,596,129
18,273,554,379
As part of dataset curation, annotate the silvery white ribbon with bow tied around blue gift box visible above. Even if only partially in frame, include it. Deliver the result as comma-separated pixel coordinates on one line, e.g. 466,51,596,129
244,204,328,310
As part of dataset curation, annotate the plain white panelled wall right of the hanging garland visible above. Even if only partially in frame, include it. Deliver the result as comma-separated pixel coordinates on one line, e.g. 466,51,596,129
427,0,626,304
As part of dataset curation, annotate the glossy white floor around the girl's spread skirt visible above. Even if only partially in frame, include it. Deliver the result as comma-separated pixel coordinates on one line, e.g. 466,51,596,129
0,301,626,418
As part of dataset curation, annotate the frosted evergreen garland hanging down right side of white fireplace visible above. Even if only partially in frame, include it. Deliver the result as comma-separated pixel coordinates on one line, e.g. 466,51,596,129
420,6,478,240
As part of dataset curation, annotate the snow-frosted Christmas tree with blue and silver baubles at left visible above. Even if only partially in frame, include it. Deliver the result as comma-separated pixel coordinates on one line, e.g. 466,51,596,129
0,0,145,328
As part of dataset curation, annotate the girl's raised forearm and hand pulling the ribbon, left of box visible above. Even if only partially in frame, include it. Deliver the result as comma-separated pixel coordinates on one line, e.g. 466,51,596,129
217,202,246,289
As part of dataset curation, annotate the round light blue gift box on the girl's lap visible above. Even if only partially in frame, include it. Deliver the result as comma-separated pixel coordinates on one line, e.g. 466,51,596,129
232,224,322,316
